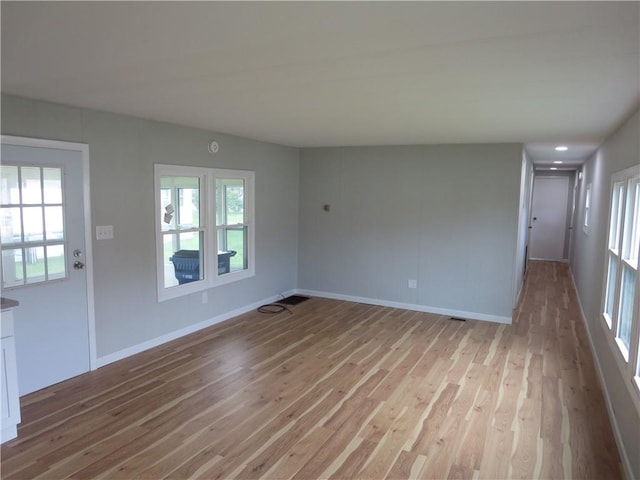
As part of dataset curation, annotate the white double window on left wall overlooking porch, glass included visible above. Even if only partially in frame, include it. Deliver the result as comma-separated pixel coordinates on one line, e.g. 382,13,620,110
155,165,255,301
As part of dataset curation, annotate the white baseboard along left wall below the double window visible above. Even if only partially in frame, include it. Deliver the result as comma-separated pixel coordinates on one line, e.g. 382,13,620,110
97,290,294,368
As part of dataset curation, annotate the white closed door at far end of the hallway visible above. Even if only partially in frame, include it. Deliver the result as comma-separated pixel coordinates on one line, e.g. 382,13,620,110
529,177,569,260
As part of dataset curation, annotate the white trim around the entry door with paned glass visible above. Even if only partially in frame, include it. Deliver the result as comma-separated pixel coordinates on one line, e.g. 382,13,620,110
0,135,98,370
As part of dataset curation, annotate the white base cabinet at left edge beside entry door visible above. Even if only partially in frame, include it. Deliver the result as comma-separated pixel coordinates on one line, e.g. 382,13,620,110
0,310,20,443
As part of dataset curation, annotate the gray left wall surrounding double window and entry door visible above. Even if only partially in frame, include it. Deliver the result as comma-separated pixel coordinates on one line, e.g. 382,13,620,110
2,95,298,358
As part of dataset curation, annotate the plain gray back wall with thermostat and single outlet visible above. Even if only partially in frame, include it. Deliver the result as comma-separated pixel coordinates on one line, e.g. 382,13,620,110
298,144,522,320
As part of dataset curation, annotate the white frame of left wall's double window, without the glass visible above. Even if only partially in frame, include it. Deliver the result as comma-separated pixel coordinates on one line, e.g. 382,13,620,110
154,164,256,302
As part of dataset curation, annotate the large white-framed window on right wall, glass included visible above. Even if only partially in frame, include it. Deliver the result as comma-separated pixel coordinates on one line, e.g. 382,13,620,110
602,166,640,396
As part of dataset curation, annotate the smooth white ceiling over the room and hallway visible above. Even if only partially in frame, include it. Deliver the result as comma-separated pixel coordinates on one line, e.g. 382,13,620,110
1,1,640,165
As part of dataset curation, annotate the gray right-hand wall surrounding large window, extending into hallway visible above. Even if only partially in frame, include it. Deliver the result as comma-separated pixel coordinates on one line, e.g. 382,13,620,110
571,107,640,478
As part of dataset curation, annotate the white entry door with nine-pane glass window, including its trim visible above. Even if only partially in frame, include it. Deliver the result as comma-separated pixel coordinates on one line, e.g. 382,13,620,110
0,137,95,395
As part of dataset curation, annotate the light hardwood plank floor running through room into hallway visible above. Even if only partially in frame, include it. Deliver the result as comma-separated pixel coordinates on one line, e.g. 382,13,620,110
2,262,622,480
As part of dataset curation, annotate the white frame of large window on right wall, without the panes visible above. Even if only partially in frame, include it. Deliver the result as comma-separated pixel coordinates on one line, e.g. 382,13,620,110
600,165,640,404
